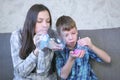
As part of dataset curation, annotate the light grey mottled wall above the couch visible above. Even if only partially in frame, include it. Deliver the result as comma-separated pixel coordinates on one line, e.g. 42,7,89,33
0,0,120,33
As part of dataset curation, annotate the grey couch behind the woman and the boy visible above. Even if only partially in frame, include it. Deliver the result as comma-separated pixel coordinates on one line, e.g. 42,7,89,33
0,27,120,80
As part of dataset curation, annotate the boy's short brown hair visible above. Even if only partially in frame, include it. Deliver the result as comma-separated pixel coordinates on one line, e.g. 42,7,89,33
56,15,77,34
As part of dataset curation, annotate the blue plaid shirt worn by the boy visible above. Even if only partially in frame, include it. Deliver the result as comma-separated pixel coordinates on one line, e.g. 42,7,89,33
55,43,102,80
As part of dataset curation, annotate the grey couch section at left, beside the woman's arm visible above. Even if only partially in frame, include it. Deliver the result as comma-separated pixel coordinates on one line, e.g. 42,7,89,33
0,33,13,80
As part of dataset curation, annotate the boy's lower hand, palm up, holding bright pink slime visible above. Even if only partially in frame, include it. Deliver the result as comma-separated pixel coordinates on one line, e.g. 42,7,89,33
70,49,85,58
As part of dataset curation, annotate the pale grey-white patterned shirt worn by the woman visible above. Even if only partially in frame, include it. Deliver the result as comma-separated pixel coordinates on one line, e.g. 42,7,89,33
10,30,57,80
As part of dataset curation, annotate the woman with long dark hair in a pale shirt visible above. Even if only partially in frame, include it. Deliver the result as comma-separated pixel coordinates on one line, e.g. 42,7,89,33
10,4,60,80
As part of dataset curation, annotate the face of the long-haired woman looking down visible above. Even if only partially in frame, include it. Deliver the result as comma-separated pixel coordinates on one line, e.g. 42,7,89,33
35,10,50,34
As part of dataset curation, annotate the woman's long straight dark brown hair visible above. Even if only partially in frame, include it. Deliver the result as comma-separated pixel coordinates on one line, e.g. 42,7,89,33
19,4,52,59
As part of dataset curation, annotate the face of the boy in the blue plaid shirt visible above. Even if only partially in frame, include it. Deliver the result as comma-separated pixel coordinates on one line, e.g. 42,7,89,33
60,28,78,49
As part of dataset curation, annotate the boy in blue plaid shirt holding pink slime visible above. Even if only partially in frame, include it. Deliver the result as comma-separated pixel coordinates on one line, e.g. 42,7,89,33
55,16,111,80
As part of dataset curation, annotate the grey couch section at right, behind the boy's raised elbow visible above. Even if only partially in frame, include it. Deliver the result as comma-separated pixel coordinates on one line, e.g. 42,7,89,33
79,27,120,80
